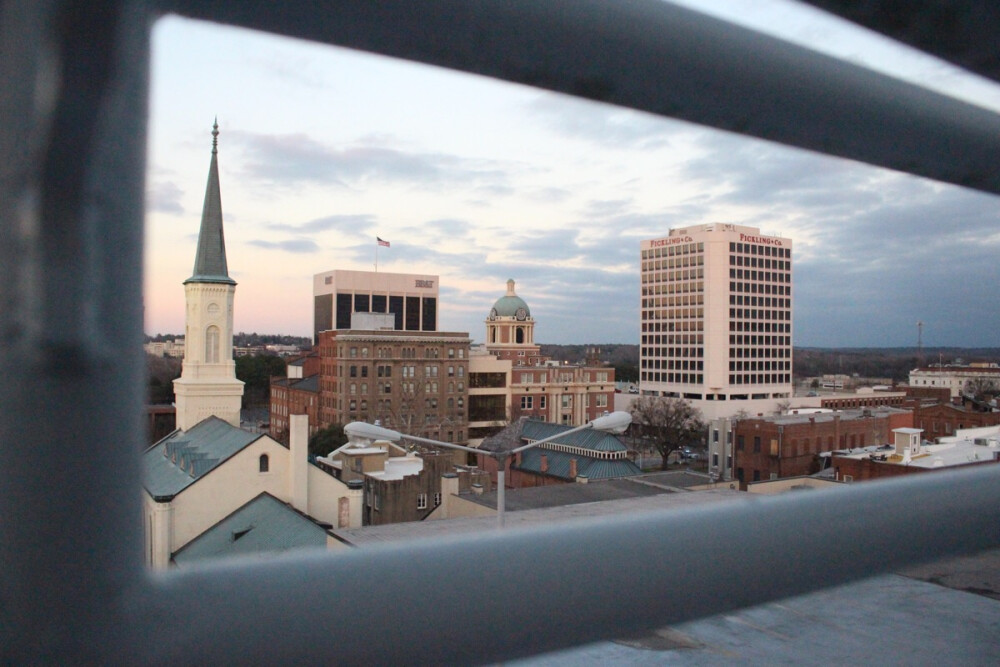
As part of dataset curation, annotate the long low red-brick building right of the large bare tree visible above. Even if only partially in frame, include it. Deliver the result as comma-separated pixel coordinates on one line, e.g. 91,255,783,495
728,407,913,490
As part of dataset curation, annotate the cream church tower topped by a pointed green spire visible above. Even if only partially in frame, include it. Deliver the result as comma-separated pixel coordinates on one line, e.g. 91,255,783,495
174,122,243,431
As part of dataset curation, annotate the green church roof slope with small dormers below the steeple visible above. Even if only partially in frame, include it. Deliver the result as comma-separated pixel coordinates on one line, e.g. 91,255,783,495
142,416,264,501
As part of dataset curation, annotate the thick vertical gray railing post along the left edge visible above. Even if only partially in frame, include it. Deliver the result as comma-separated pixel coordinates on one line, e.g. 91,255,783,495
0,1,149,664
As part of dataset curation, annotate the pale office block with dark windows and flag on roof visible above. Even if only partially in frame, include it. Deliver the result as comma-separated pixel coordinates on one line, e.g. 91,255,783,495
313,270,438,344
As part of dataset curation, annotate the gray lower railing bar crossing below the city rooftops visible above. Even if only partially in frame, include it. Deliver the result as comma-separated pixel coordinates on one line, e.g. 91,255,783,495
136,465,1000,664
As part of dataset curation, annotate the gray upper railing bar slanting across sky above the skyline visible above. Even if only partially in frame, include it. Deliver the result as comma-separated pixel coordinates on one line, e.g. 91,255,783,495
158,0,1000,193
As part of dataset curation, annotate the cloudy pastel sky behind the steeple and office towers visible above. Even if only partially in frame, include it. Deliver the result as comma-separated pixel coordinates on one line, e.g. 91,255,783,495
144,0,1000,347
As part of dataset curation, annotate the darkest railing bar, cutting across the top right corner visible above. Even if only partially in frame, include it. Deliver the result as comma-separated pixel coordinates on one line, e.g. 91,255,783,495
802,0,1000,81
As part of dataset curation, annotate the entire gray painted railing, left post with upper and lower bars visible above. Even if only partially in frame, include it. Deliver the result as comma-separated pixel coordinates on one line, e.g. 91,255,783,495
0,0,1000,663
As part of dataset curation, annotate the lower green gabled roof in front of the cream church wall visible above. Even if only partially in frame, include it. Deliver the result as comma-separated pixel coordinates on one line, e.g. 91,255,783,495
173,493,326,565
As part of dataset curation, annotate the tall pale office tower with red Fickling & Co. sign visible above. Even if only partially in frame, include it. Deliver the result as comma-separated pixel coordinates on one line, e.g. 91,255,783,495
640,223,792,419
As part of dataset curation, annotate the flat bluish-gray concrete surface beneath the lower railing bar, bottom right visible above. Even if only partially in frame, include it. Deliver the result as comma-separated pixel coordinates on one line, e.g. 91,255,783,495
506,564,1000,667
